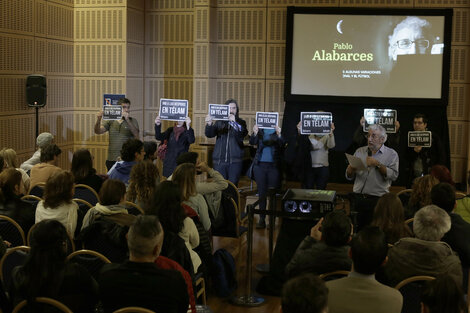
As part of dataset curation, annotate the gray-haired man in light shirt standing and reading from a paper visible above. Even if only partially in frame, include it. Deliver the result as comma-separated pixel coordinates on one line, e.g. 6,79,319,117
346,124,399,230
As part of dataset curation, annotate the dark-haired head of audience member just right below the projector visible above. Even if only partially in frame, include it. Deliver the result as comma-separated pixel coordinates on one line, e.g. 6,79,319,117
321,210,352,247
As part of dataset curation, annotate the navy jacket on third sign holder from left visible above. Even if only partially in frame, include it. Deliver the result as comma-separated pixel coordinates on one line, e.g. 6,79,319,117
205,118,248,164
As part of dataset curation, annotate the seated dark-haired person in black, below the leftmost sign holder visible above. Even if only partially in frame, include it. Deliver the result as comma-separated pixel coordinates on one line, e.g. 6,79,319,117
70,149,103,193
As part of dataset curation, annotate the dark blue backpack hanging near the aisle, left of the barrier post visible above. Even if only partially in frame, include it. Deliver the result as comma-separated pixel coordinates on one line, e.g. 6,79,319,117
212,248,238,297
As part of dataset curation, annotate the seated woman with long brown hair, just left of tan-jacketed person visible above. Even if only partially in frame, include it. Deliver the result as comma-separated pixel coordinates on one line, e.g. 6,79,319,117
172,163,211,230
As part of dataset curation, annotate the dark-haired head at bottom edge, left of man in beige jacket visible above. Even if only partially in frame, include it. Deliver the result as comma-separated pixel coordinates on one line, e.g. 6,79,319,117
281,274,328,313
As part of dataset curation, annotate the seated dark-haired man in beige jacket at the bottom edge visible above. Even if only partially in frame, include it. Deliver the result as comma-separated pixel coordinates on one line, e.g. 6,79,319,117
326,226,403,313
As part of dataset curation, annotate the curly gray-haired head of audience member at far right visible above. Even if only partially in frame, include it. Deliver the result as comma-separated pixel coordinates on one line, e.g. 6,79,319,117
413,204,450,241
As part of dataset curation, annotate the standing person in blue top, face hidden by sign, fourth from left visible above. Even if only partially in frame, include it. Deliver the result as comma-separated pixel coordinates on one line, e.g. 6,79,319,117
250,125,284,228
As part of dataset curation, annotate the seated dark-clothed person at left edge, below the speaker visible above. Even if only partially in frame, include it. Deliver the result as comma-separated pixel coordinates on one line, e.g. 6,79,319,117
0,168,35,234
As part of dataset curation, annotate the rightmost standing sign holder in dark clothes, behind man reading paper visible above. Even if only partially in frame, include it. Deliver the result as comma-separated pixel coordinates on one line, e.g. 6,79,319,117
406,113,445,188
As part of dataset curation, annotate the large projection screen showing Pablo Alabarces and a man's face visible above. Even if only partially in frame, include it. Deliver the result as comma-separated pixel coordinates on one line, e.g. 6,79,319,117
285,7,452,105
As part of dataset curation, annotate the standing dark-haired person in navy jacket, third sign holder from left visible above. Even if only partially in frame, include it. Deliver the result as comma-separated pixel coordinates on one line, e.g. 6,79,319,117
205,99,248,186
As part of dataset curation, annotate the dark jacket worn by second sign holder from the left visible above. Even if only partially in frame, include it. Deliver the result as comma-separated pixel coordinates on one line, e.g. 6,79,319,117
155,124,196,177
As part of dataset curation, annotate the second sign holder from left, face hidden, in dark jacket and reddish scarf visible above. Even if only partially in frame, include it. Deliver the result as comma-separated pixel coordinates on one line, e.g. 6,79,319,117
155,116,196,177
